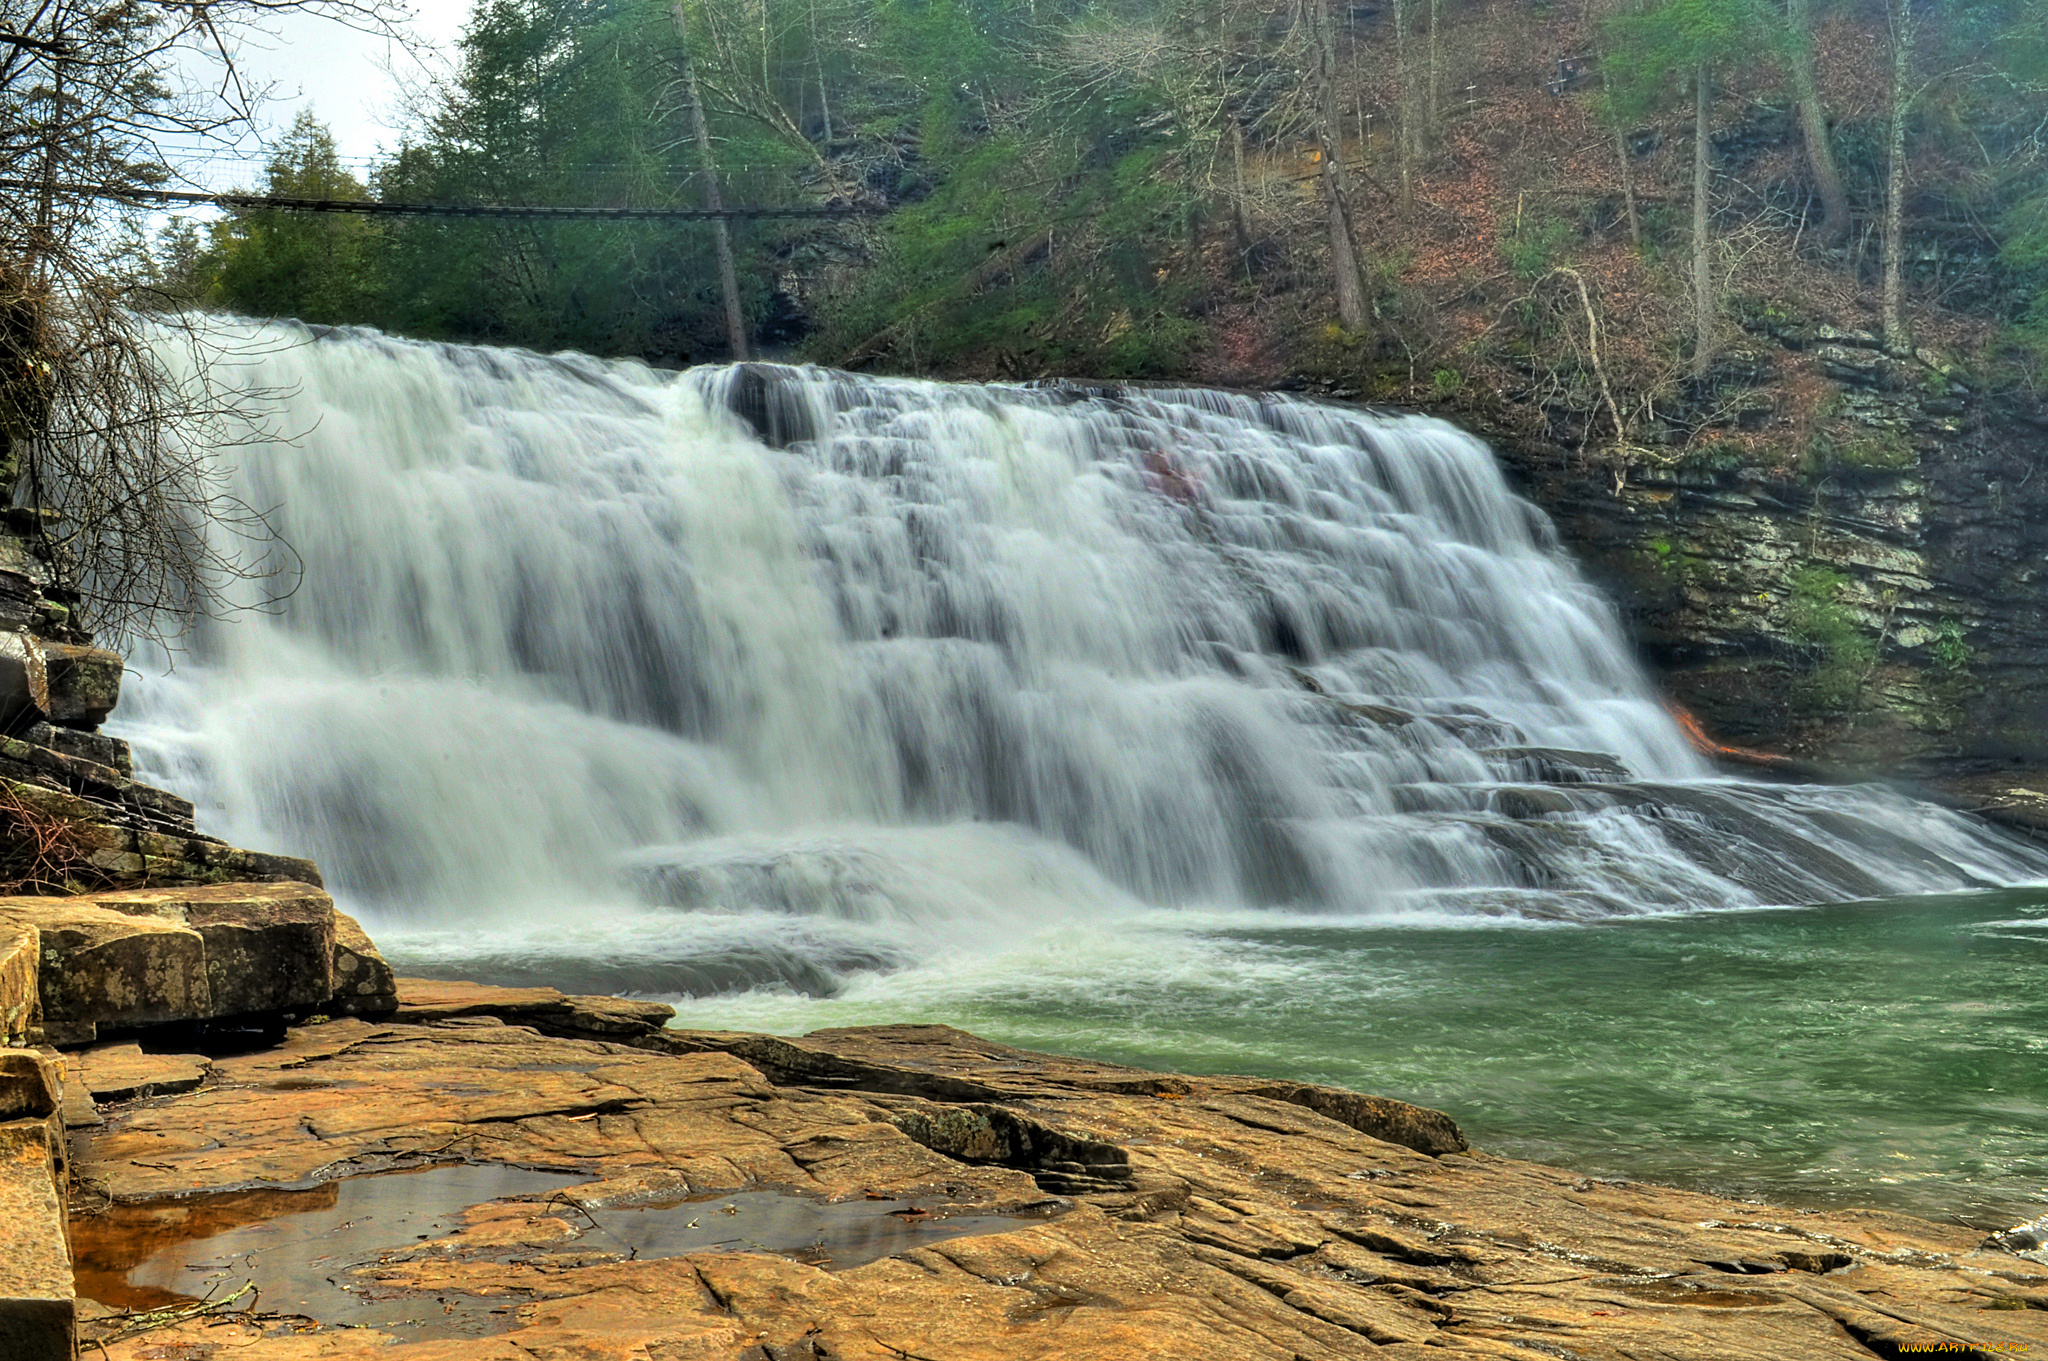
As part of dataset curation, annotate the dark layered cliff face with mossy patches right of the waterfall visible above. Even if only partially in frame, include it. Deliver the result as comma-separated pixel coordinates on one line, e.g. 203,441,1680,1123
1499,317,2048,774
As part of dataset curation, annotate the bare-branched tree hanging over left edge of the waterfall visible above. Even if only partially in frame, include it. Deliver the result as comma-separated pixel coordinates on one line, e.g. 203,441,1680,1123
0,0,399,639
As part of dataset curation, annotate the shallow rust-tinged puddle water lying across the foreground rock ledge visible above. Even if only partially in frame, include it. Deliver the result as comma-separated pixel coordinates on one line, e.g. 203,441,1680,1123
72,1162,1064,1338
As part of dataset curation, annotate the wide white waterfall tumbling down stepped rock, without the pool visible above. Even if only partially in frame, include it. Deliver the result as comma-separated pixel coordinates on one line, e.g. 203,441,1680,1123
117,321,2048,991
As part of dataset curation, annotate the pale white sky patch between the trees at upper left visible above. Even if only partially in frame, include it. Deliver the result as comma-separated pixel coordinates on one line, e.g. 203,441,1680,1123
180,0,473,190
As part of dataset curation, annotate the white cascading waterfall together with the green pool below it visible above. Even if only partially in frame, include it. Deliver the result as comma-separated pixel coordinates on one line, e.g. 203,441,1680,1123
117,321,2048,1224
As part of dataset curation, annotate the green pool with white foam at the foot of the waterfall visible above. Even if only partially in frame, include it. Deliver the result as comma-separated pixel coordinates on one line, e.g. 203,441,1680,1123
651,890,2048,1228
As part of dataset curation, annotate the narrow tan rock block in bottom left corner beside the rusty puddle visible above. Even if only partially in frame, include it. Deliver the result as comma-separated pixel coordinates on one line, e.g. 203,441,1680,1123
0,1119,78,1361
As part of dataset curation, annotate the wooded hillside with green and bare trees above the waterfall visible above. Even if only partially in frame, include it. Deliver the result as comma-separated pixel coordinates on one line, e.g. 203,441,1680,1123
103,0,2048,467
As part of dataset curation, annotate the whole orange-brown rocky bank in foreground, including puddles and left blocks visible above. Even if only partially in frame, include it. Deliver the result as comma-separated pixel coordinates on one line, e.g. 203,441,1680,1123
0,884,2048,1361
